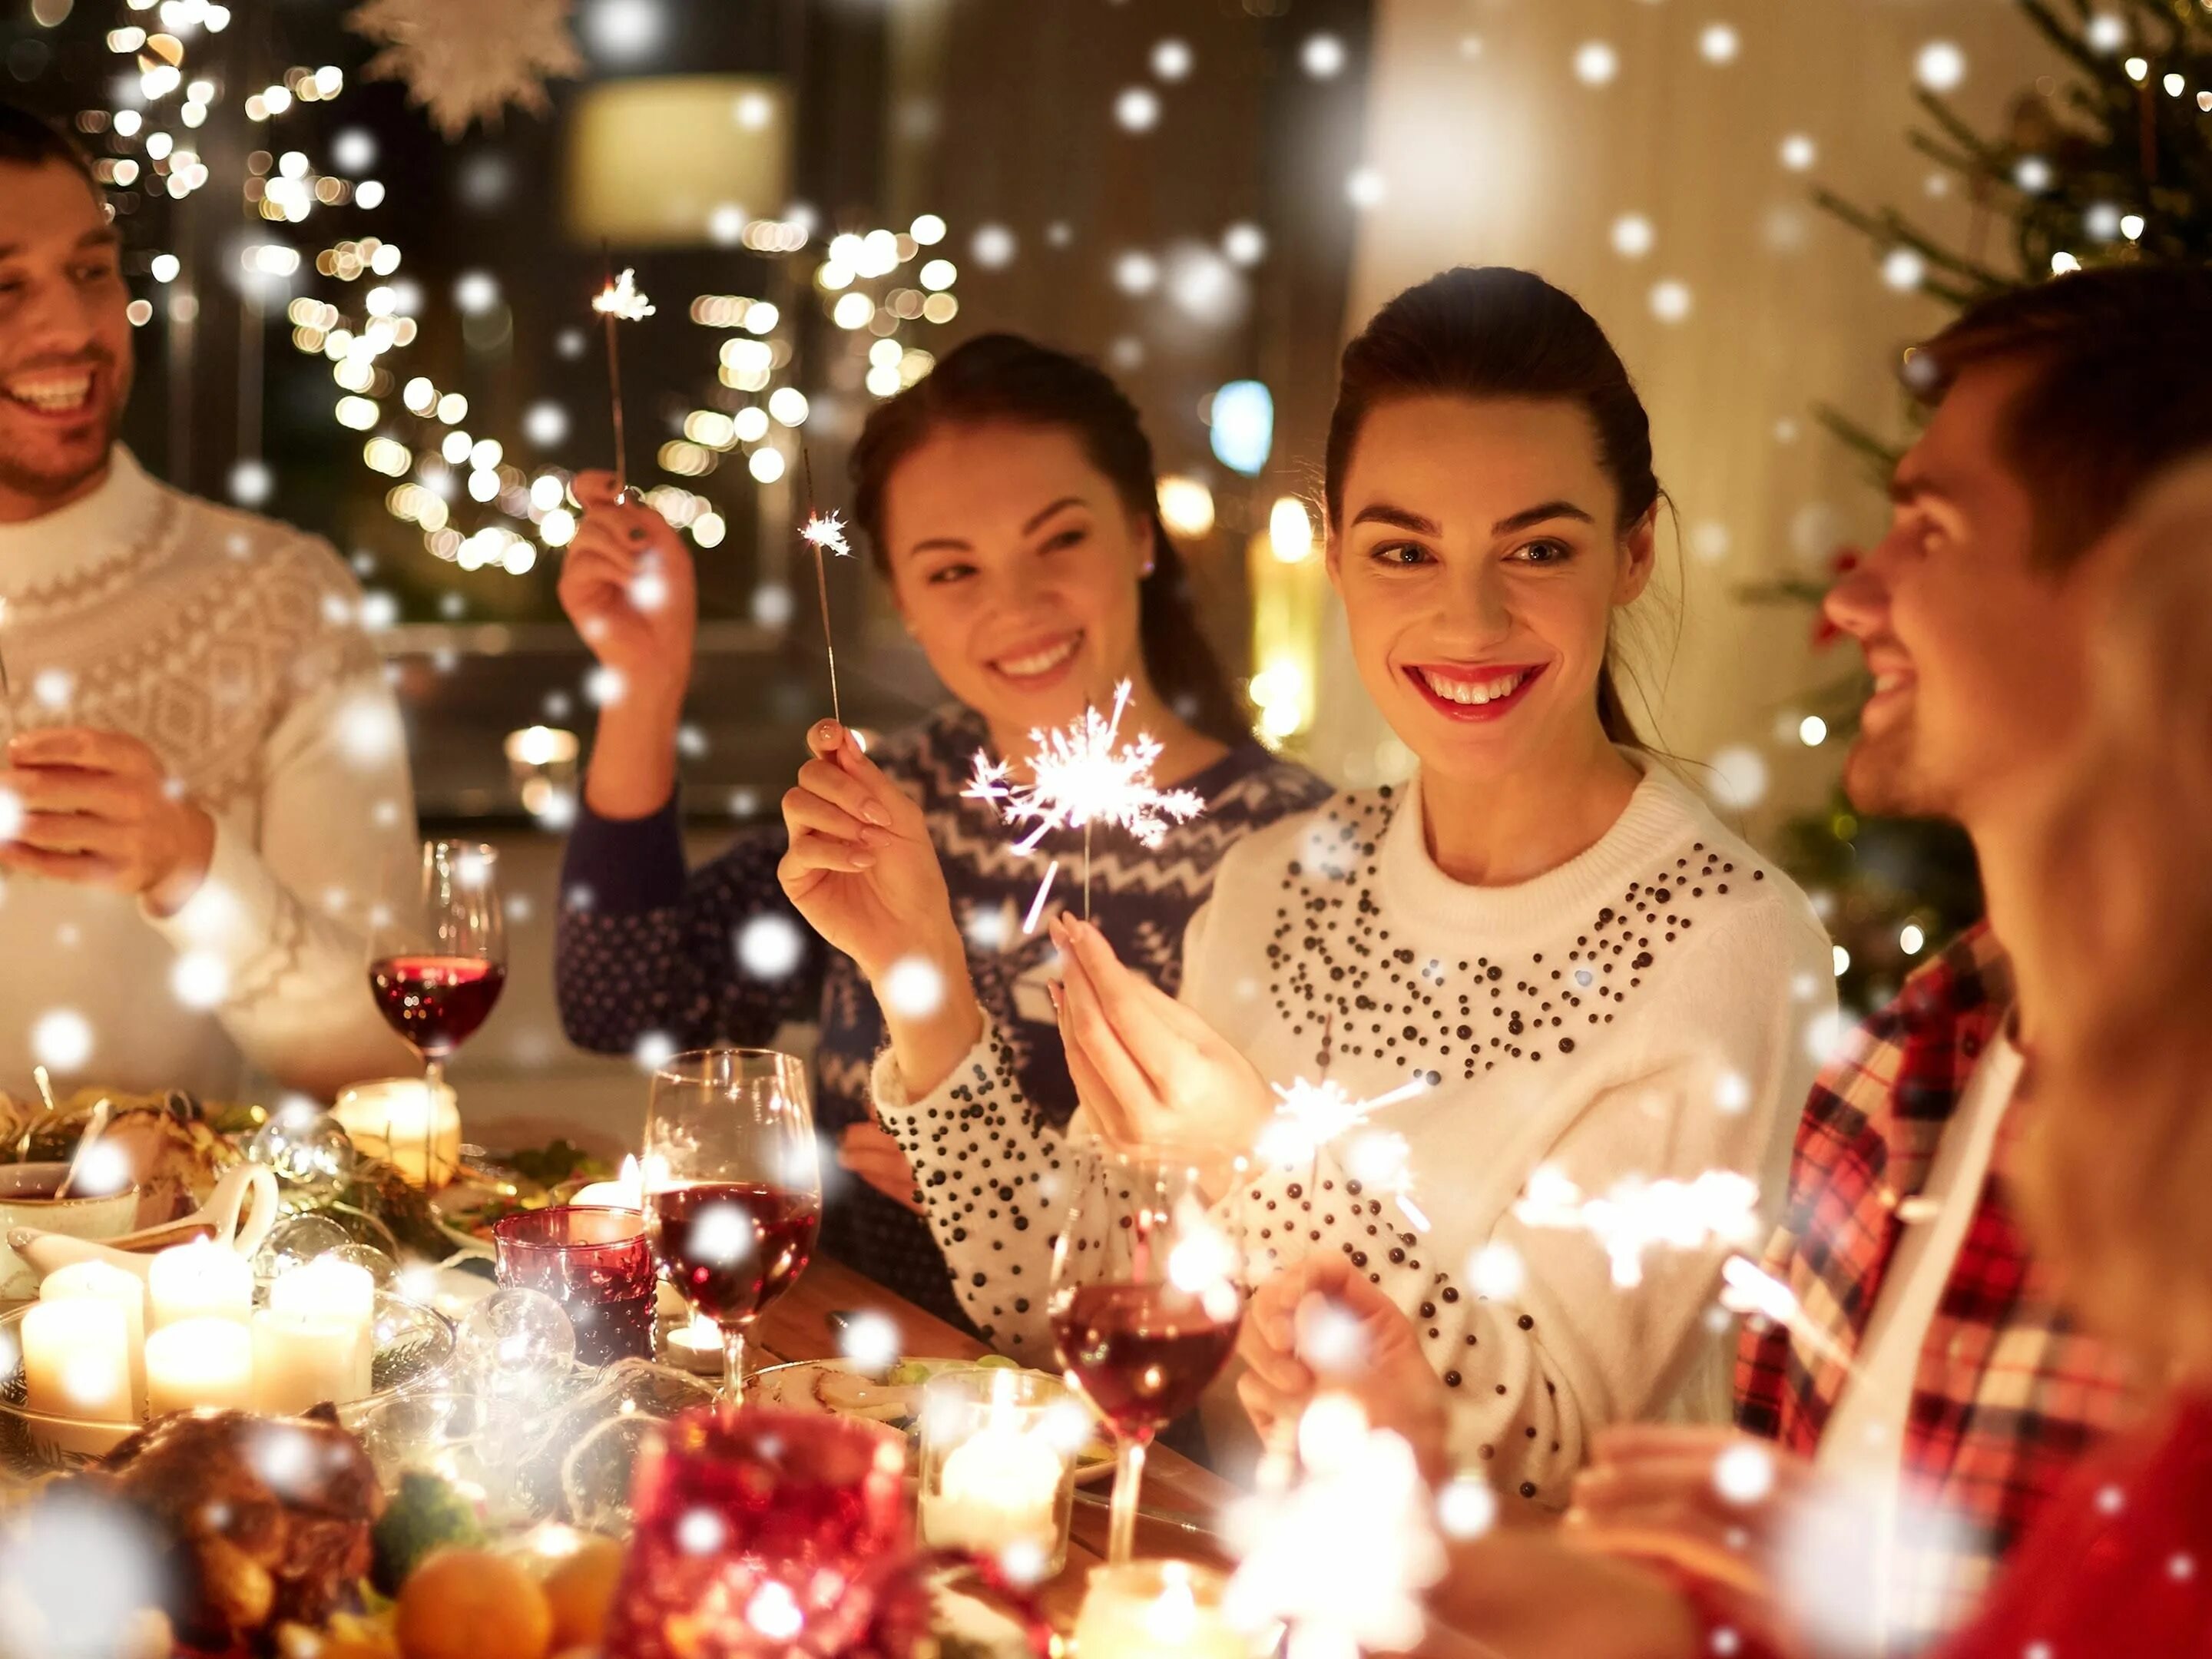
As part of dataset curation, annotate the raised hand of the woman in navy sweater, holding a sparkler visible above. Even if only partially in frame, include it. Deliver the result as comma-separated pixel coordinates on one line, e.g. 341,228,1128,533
560,471,699,708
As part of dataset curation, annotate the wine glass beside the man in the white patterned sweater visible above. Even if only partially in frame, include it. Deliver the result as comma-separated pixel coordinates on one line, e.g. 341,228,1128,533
369,840,507,1174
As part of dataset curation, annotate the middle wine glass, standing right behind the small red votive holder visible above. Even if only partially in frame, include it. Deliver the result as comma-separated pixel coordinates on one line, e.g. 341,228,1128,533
644,1048,823,1407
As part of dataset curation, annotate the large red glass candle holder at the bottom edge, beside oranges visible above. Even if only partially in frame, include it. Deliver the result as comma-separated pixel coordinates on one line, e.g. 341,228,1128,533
606,1405,913,1659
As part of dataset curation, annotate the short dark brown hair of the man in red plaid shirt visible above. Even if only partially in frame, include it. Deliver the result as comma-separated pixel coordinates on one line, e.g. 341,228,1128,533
1905,266,2212,571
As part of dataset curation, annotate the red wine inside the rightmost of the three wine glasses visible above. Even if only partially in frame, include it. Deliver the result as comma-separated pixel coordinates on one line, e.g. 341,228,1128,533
1053,1285,1241,1438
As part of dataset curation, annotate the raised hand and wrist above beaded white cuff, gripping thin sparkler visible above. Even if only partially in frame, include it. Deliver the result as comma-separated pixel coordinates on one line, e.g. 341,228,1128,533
777,721,982,1095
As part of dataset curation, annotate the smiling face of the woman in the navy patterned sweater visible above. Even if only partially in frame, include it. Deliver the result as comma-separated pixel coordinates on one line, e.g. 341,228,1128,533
882,422,1152,730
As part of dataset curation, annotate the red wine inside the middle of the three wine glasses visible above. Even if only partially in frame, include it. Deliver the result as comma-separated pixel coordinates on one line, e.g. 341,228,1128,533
646,1181,823,1325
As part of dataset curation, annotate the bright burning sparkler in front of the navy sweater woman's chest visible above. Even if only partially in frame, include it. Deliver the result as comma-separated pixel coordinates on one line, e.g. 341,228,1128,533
962,679,1206,920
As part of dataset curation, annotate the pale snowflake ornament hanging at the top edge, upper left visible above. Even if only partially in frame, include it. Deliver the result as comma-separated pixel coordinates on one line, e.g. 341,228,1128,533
345,0,584,144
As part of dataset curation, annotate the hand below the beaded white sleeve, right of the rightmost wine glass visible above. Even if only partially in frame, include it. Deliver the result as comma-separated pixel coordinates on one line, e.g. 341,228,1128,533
1237,1257,1449,1480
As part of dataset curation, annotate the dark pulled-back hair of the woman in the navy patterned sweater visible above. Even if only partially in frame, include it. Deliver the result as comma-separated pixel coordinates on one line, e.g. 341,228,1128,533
852,334,1250,743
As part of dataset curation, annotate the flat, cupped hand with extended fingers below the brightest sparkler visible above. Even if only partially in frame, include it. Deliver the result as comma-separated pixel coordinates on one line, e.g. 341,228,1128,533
1053,916,1274,1167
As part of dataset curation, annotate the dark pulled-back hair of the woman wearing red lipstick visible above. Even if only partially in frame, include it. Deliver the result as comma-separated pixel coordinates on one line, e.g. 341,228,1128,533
1325,266,1661,747
